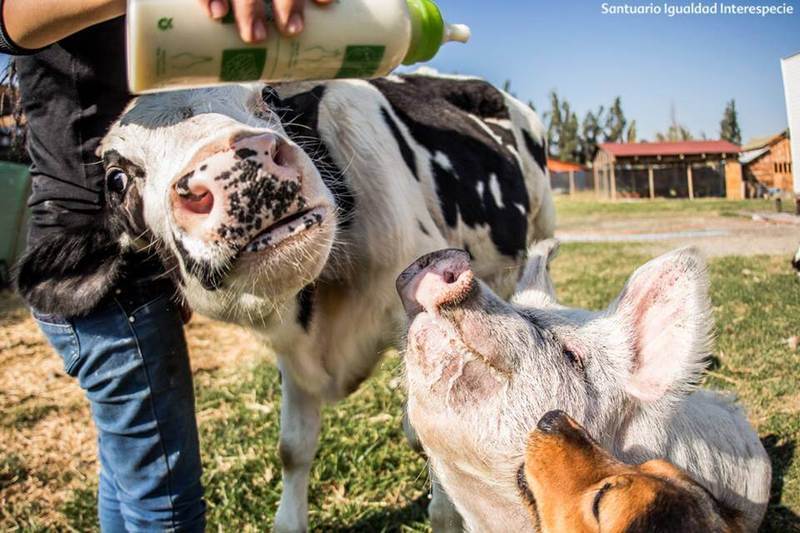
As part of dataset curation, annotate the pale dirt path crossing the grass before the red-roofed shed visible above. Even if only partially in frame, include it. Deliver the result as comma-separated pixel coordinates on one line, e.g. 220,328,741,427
556,214,800,257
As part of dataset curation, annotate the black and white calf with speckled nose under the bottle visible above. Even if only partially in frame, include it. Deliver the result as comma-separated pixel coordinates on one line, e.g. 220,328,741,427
18,75,555,531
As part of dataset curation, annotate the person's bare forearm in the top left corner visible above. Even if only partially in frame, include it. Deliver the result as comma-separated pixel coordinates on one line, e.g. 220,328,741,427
0,0,126,50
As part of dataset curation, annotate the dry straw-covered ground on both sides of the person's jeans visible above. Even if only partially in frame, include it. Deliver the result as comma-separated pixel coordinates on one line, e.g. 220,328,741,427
0,292,268,530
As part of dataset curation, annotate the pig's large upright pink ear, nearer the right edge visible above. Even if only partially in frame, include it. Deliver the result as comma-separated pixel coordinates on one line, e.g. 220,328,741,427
611,248,712,402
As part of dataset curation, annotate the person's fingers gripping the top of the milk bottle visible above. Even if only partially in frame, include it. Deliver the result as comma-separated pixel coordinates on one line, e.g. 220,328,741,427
199,0,333,43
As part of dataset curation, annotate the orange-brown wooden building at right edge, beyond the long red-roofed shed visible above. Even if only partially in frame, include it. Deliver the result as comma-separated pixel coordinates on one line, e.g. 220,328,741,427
739,130,793,197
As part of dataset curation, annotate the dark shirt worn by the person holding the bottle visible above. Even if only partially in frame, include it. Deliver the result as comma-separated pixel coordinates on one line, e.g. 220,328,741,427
12,16,131,244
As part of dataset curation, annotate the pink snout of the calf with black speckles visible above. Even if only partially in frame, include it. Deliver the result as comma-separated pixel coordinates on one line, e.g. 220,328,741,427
171,133,302,239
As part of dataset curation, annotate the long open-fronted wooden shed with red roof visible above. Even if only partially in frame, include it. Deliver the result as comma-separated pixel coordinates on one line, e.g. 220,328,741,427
592,141,744,199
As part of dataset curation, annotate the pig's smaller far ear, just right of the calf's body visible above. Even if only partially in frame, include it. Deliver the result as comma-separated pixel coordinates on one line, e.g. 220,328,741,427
511,239,559,308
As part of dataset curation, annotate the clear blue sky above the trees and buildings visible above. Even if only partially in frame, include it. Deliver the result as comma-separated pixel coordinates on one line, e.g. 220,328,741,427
422,0,800,140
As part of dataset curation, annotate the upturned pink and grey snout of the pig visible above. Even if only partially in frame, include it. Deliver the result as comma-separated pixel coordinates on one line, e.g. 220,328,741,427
397,250,475,316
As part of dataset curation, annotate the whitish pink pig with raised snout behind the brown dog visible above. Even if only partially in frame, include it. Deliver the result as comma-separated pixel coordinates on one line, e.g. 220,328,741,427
397,242,770,531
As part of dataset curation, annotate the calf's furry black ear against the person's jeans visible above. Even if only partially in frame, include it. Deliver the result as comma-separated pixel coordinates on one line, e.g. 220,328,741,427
14,227,123,317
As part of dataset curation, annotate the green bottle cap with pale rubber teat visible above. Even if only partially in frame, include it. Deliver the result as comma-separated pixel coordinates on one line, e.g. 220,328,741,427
403,0,470,65
